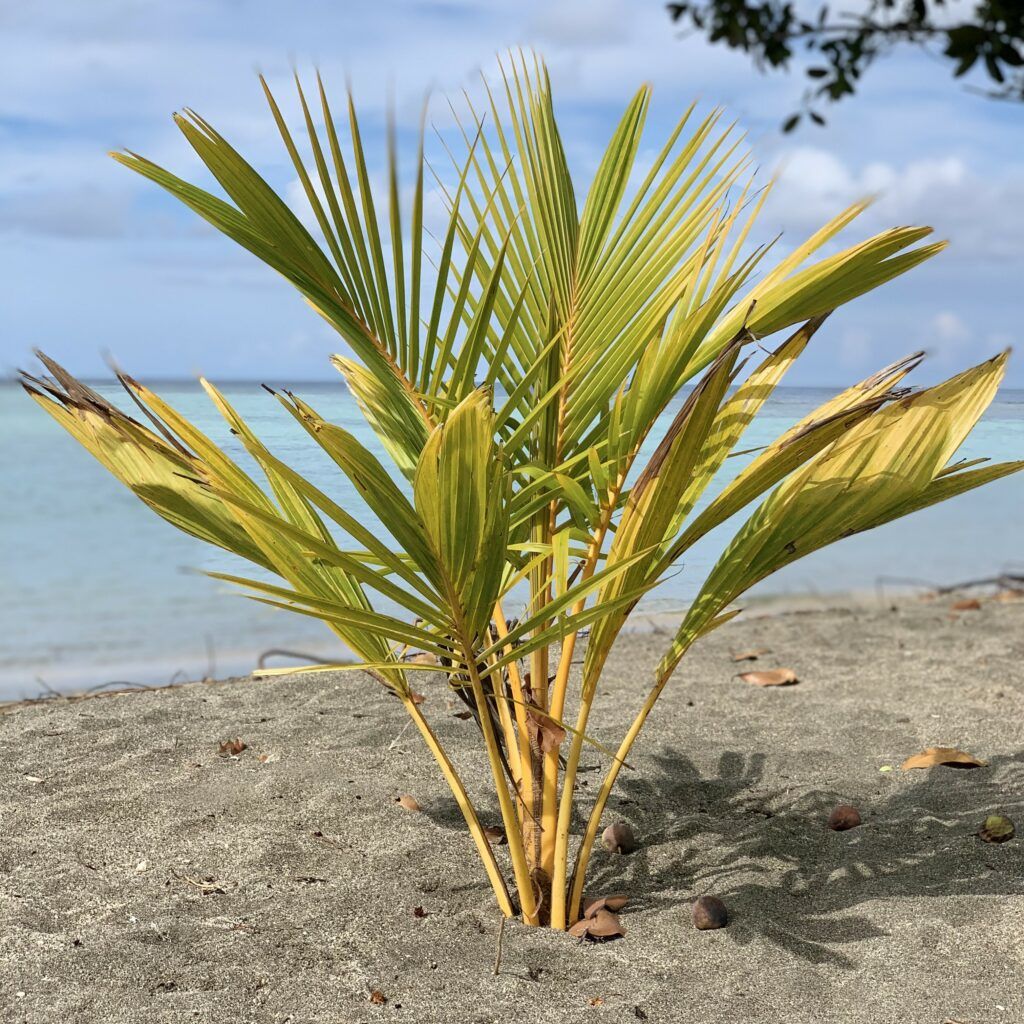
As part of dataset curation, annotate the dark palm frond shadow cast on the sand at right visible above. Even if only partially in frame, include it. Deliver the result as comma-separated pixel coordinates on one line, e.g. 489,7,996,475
587,749,1024,967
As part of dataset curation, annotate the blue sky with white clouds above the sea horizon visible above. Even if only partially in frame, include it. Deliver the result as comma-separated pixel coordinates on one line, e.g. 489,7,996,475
0,0,1024,386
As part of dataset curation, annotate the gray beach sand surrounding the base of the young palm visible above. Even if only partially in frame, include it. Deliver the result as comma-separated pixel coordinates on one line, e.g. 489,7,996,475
0,598,1024,1024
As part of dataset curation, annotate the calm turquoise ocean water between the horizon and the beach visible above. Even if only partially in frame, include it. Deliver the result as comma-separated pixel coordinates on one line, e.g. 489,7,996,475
0,382,1024,698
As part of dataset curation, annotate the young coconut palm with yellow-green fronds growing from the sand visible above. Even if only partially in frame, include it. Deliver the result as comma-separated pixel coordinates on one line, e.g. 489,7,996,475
25,57,1024,929
